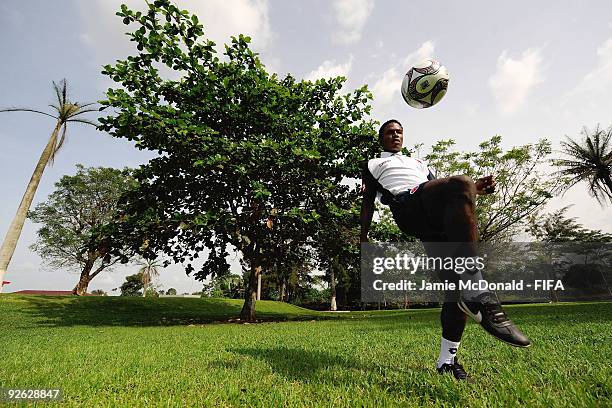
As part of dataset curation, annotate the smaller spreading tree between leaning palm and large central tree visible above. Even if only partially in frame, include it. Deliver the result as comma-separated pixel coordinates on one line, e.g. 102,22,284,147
28,164,135,295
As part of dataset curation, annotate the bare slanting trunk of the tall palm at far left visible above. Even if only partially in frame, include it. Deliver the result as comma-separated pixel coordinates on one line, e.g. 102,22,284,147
0,121,62,292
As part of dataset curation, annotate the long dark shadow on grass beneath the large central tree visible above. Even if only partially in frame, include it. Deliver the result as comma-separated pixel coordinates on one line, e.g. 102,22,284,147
0,296,337,328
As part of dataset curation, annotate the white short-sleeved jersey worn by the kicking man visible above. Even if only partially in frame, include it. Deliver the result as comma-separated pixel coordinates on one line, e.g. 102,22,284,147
368,152,430,195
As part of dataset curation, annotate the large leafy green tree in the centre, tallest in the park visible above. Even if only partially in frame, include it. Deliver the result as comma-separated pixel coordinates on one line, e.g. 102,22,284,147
95,0,376,320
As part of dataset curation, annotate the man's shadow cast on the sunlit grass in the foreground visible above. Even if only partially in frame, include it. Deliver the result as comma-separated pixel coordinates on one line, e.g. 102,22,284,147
228,346,437,400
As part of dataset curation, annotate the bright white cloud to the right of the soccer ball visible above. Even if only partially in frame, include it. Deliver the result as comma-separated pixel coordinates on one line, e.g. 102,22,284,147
489,48,544,114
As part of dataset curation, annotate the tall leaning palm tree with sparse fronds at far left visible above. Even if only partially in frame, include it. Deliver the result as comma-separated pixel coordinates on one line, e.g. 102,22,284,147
0,79,97,292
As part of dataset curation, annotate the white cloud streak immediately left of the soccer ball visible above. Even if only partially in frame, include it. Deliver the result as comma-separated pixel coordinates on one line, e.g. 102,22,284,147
372,41,435,105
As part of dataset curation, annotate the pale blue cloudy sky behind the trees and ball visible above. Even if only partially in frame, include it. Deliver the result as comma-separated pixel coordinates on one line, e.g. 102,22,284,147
0,0,612,294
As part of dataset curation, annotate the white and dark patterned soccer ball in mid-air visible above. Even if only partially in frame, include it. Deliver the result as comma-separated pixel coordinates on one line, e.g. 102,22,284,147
402,59,448,109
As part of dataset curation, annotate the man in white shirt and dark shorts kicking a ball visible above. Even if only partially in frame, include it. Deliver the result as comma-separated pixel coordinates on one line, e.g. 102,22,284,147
361,119,530,380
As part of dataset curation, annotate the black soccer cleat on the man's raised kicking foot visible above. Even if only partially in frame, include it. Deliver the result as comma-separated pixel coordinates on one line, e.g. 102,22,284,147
459,292,531,347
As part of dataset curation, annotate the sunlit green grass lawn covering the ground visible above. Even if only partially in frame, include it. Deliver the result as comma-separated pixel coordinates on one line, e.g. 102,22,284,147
0,295,612,407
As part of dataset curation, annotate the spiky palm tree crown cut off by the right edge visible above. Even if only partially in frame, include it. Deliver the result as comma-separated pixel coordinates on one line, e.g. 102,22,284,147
555,125,612,204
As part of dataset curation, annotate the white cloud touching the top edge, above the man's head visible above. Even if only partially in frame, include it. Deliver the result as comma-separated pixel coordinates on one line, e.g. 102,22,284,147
333,0,374,44
